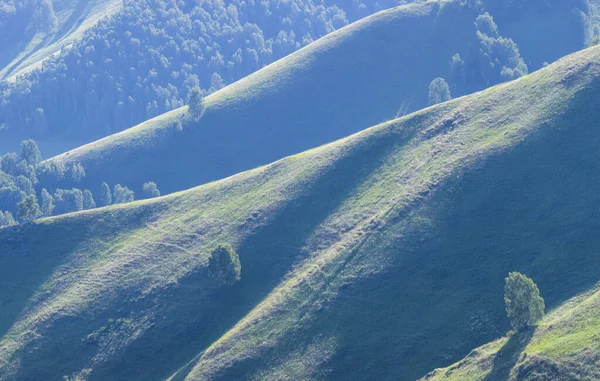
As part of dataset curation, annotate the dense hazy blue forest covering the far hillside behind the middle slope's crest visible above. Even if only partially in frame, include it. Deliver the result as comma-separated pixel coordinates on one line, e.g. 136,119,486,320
0,0,403,137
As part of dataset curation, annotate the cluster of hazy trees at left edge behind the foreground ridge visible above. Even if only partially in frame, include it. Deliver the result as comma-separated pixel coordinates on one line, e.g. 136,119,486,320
0,140,160,227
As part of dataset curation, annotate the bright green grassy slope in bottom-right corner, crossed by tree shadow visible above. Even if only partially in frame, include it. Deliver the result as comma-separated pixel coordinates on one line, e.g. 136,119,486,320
423,288,600,381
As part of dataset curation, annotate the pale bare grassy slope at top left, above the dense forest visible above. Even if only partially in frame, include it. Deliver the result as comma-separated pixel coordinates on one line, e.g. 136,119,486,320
0,0,122,80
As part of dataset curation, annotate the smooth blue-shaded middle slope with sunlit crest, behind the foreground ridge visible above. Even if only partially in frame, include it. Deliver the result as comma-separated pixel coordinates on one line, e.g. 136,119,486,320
49,1,486,192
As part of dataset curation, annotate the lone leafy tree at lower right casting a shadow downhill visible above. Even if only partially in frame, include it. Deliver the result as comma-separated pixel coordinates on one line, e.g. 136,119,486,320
504,272,545,330
